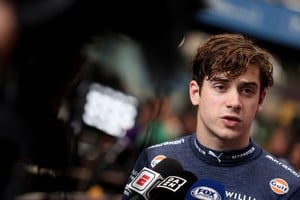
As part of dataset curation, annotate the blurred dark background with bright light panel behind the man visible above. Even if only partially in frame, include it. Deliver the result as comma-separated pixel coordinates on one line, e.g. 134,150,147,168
0,0,300,200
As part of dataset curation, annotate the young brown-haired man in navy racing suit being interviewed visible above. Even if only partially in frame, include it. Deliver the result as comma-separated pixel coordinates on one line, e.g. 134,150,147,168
123,34,300,200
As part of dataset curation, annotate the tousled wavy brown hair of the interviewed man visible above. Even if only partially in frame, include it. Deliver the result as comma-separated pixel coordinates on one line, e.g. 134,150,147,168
192,33,273,94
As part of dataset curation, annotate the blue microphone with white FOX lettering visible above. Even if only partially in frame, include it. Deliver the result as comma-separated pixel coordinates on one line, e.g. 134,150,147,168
185,179,226,200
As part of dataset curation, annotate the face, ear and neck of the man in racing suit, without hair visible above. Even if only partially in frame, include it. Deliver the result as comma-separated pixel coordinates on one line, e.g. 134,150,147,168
190,65,265,149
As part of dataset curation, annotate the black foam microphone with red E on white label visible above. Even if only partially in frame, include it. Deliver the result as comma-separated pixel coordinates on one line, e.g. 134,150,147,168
128,158,183,200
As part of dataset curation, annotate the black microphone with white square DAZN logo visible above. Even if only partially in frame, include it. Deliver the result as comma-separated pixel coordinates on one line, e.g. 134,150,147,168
150,171,198,200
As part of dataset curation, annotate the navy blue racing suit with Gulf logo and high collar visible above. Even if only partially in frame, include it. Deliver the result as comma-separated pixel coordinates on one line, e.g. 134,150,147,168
122,134,300,200
